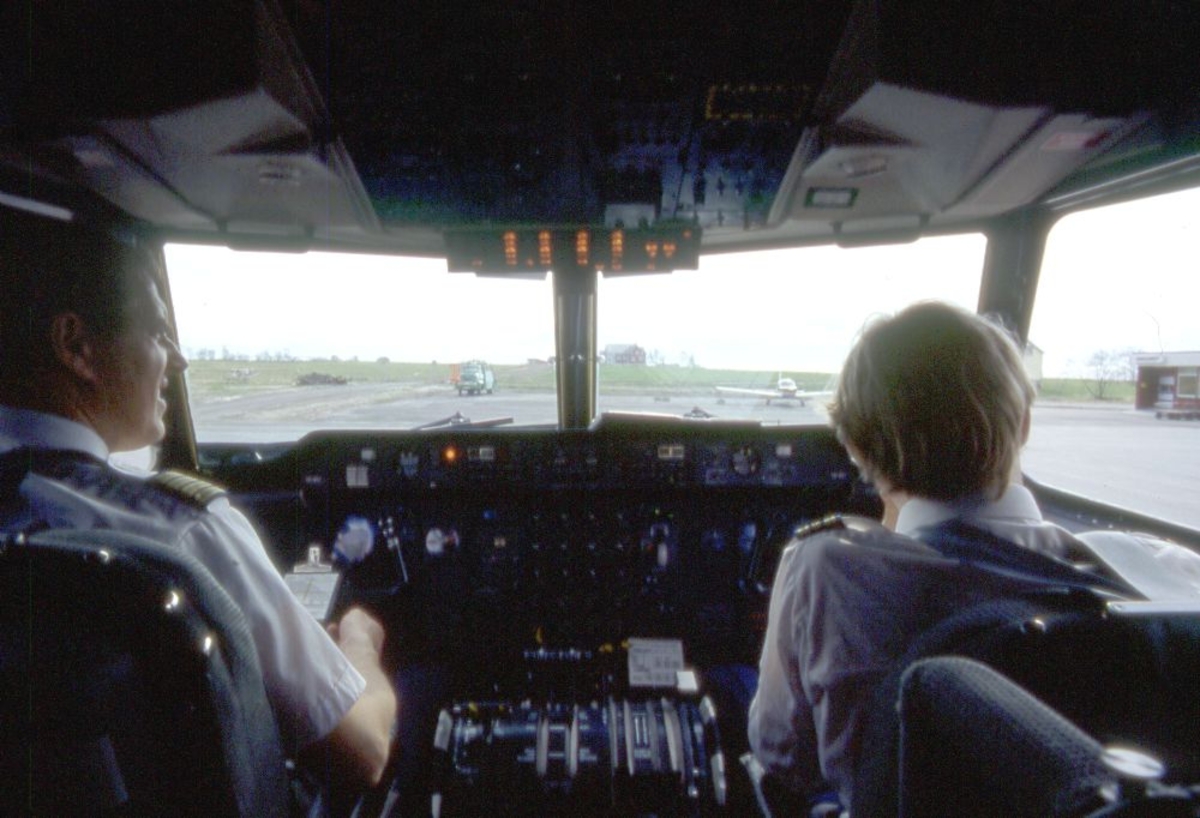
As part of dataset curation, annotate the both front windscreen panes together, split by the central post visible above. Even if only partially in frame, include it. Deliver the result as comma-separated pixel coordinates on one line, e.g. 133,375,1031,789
167,235,985,444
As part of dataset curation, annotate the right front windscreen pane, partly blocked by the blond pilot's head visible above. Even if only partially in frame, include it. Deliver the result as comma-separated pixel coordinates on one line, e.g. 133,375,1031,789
598,234,986,423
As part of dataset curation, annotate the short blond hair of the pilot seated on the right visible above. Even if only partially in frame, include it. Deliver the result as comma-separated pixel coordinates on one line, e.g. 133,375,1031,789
829,301,1036,500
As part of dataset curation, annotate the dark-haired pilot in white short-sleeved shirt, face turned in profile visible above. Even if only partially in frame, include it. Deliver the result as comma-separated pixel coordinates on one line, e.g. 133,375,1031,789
0,212,396,784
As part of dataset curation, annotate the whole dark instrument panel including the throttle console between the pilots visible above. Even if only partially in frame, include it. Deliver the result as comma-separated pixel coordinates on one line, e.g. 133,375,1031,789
202,419,881,814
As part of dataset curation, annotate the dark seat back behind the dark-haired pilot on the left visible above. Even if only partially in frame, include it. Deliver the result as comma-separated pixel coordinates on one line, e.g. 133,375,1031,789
0,530,289,817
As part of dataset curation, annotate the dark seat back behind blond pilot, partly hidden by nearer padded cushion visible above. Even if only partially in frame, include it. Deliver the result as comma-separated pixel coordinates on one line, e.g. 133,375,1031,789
852,591,1200,816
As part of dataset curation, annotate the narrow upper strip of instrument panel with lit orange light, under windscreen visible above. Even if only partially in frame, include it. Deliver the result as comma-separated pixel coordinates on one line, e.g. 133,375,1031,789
300,419,854,492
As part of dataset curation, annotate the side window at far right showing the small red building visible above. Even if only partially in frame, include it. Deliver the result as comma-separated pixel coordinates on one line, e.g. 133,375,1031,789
1022,190,1200,528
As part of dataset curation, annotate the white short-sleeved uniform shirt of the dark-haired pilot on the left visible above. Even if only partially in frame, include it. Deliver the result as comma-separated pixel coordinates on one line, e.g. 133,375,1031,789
0,407,366,751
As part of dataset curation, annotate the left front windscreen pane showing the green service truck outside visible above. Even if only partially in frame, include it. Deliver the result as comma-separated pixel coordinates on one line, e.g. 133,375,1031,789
166,245,558,443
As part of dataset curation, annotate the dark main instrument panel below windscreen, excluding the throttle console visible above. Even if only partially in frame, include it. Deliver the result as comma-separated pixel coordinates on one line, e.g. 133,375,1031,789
243,423,878,697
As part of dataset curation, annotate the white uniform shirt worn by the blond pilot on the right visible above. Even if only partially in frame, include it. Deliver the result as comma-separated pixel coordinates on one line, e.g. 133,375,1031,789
749,486,1099,806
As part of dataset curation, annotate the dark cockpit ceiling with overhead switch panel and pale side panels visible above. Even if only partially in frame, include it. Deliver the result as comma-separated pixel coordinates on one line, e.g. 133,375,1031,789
0,0,1200,255
